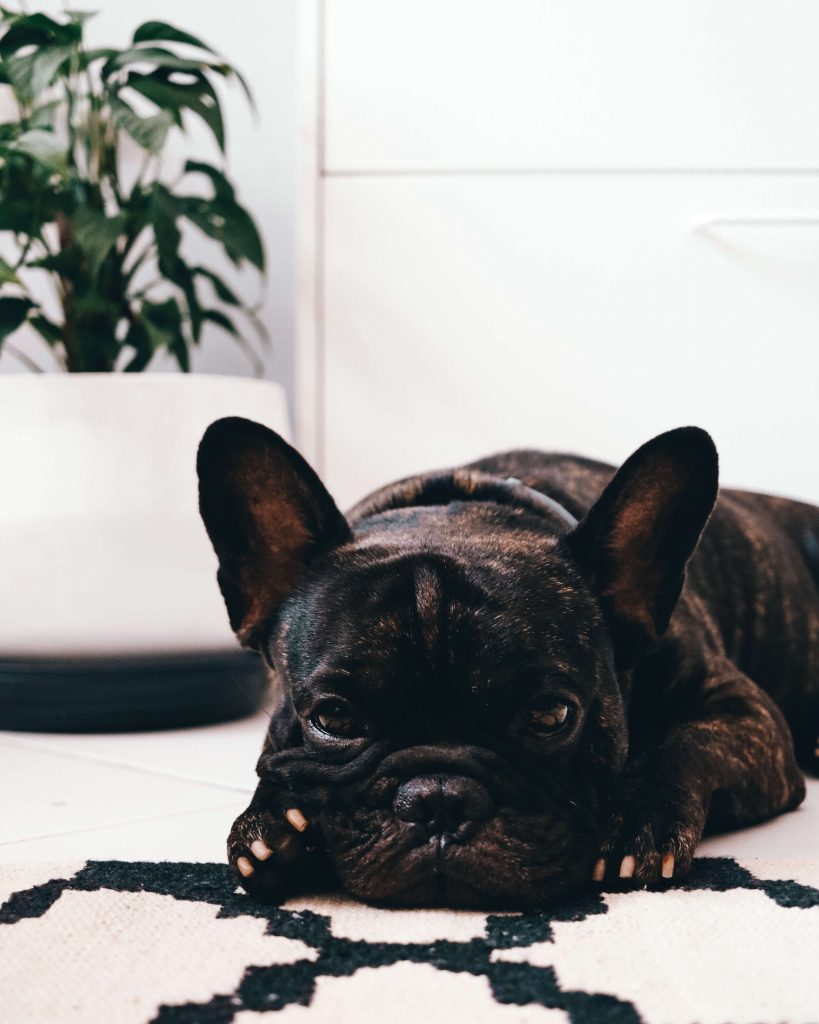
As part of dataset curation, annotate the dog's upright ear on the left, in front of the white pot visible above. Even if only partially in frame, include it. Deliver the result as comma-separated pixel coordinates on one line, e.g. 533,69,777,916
197,417,350,650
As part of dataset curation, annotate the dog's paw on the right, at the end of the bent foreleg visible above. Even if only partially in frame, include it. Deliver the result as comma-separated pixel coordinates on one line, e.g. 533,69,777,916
592,792,705,888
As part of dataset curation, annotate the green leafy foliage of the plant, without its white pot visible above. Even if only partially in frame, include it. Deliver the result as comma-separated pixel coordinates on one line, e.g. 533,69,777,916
0,4,264,373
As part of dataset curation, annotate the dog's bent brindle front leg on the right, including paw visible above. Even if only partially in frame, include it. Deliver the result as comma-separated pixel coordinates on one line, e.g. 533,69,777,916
594,662,805,885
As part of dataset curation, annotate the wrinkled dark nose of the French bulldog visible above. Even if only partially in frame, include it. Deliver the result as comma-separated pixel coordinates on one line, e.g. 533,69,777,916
392,775,494,836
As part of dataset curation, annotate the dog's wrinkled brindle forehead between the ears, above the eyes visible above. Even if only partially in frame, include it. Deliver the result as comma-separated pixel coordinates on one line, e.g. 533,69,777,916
274,509,599,698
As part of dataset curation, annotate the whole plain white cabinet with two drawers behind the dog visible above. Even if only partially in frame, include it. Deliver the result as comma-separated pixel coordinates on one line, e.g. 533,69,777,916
301,0,819,512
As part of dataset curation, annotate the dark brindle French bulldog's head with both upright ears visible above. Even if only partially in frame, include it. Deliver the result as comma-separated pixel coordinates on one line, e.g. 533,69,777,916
199,419,717,906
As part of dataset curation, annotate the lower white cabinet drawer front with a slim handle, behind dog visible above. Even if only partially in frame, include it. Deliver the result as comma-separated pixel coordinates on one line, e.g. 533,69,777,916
325,175,819,503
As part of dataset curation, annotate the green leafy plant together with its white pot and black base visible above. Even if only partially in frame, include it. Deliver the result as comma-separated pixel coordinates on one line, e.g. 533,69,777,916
0,8,287,728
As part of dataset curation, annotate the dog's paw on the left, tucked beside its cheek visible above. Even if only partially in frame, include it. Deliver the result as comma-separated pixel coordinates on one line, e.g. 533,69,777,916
227,805,318,901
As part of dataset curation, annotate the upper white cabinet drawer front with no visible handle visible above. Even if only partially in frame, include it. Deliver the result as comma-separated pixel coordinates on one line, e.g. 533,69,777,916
325,0,819,172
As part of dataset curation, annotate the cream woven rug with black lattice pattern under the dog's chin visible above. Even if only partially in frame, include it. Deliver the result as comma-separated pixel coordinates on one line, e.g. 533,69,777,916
0,858,819,1024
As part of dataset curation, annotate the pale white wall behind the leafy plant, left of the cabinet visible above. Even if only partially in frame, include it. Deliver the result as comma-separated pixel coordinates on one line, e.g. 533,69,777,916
0,0,298,411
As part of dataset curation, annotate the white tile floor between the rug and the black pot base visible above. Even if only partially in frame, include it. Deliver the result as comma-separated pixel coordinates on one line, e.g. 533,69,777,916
0,713,819,863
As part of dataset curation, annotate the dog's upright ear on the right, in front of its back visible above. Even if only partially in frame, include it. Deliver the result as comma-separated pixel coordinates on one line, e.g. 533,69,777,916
566,427,718,667
